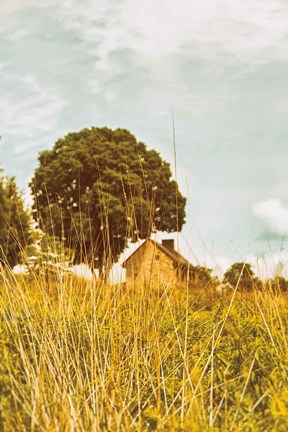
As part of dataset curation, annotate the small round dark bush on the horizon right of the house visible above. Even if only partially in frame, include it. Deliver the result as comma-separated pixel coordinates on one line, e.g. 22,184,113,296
224,262,261,291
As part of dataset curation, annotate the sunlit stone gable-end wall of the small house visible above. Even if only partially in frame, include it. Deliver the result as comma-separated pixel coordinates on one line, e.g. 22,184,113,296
126,241,177,289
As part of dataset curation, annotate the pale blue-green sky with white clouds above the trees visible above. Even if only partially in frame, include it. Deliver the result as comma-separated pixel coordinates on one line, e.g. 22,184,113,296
0,0,288,275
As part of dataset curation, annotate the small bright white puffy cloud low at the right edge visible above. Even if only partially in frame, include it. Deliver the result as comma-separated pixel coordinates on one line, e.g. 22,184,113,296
253,198,288,235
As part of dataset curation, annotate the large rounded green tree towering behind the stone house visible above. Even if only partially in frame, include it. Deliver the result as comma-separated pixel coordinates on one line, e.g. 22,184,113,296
30,128,186,269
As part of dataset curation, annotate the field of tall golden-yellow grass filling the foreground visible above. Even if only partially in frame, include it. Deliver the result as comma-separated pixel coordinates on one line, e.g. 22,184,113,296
0,272,288,432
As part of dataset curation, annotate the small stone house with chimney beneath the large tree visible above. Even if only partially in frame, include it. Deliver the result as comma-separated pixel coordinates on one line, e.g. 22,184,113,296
122,239,195,288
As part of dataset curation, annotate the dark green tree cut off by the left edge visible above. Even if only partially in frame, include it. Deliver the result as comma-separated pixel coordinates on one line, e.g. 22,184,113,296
0,171,32,267
